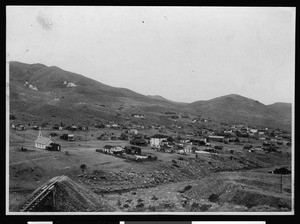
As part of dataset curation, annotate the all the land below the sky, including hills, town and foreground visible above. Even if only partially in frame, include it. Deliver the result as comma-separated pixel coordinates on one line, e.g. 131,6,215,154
7,61,293,213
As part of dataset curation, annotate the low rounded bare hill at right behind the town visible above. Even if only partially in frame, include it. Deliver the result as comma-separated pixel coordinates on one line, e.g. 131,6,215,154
189,94,291,130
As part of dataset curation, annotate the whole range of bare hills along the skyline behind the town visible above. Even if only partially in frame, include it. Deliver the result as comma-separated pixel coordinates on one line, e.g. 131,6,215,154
9,61,291,131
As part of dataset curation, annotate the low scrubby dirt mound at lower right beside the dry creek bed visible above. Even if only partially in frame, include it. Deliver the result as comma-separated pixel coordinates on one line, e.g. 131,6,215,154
184,172,291,211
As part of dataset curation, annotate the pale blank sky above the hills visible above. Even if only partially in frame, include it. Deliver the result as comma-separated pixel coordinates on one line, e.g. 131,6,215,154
6,6,295,104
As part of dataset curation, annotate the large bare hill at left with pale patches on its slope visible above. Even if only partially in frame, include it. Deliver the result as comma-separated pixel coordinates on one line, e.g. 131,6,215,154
10,62,188,124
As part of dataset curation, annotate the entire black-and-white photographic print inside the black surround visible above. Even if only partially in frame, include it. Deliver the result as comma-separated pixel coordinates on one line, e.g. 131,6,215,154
5,5,296,216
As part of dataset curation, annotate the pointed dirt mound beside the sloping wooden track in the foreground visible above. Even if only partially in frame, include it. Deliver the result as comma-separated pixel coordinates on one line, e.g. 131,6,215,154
54,176,115,212
